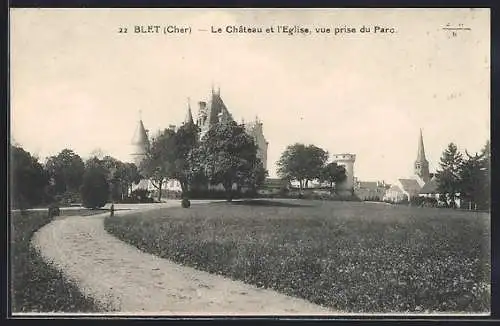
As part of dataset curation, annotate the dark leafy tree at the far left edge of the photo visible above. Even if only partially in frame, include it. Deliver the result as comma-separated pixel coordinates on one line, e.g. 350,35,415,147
10,146,48,208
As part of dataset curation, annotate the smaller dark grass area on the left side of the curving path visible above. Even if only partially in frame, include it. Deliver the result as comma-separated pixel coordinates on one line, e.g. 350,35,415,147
10,209,106,313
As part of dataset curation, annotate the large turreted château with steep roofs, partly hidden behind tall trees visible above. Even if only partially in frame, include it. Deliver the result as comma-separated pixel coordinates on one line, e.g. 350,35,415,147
131,87,269,191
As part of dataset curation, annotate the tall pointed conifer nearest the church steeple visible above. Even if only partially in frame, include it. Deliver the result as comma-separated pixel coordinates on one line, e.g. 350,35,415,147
437,143,463,204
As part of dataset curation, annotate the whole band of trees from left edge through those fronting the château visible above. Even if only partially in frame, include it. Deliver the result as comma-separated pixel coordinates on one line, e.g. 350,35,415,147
10,121,267,208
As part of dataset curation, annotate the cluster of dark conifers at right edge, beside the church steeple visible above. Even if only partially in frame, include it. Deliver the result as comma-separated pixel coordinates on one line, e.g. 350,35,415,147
437,141,491,209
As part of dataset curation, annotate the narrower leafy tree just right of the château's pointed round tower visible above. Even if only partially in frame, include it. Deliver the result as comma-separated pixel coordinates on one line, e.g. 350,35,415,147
140,128,176,201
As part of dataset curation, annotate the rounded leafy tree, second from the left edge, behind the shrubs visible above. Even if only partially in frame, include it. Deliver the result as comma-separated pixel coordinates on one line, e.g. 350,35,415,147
45,148,85,194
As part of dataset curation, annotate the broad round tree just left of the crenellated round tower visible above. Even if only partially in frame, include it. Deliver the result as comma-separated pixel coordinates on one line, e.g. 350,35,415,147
278,143,328,190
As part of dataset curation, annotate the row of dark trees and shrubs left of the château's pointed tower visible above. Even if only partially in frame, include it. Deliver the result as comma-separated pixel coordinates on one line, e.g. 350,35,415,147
10,146,141,208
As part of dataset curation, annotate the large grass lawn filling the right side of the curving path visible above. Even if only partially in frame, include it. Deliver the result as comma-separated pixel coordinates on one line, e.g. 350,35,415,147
105,200,490,313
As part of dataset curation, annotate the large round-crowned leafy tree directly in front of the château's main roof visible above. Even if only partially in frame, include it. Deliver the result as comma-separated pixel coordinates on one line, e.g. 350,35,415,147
194,121,259,201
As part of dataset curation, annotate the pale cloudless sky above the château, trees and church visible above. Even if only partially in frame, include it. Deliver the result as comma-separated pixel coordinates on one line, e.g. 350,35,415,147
10,9,490,182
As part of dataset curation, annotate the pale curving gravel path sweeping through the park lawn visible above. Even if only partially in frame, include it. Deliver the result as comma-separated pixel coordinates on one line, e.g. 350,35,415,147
32,201,334,315
